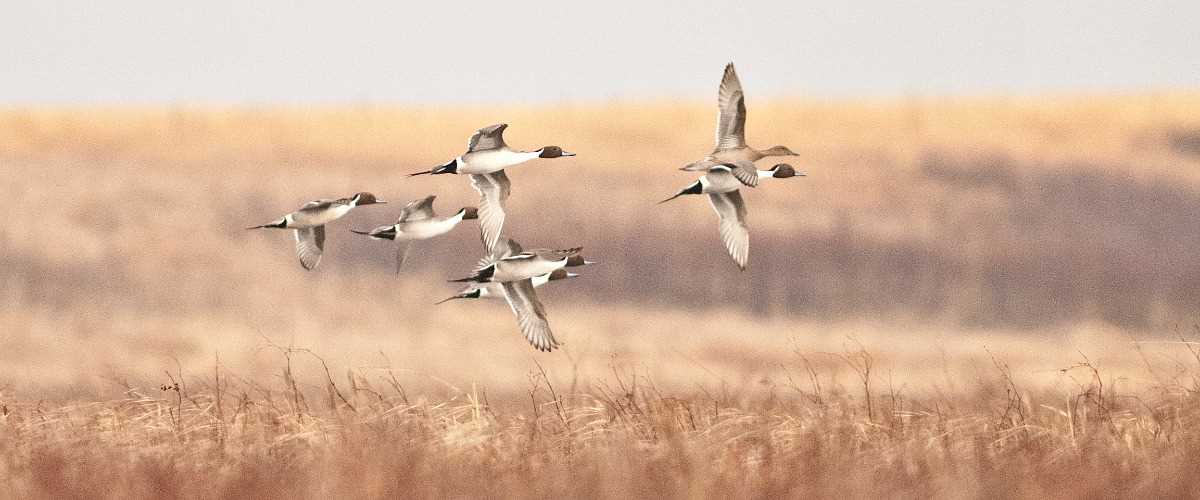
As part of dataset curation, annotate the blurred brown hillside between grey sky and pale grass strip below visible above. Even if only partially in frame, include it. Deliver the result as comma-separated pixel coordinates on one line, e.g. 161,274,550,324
0,92,1200,329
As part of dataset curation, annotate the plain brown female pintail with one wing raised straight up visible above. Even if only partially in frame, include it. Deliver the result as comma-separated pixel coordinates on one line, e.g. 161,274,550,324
680,62,796,187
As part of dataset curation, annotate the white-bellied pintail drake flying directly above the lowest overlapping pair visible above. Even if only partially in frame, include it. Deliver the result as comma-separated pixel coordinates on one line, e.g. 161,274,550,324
410,124,575,252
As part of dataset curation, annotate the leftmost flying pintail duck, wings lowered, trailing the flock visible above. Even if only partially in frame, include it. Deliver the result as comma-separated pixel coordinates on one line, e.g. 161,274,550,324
246,193,388,271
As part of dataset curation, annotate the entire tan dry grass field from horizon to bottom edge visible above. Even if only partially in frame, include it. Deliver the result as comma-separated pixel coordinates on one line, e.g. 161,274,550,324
0,91,1200,498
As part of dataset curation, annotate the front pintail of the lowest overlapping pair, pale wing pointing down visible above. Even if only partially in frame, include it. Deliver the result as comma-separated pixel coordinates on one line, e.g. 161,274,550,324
438,239,593,351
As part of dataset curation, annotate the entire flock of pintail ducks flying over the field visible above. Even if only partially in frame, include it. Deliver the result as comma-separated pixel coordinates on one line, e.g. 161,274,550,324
247,62,805,351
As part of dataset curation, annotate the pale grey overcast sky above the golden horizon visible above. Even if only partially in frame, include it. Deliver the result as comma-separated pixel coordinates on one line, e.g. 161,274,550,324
0,0,1200,104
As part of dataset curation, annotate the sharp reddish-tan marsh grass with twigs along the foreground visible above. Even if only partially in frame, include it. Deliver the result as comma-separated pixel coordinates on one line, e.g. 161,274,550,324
0,342,1200,498
